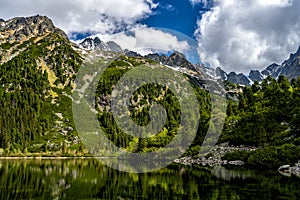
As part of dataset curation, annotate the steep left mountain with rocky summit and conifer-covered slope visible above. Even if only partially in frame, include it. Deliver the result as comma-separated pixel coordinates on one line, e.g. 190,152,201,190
0,15,82,154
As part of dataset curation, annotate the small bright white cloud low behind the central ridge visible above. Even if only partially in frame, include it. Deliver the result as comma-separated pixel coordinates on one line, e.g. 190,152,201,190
89,25,189,55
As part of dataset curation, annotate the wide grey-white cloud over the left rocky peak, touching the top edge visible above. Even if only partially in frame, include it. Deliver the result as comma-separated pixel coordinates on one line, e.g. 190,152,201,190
0,0,158,33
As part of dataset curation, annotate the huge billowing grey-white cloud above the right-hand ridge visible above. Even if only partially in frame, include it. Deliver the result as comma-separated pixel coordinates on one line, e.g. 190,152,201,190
195,0,300,72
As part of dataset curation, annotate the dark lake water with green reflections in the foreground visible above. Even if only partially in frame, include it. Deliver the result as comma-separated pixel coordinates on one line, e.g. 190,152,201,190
0,159,300,200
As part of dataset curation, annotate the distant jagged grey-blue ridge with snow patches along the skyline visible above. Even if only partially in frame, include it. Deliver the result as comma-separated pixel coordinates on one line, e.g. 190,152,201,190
79,33,300,86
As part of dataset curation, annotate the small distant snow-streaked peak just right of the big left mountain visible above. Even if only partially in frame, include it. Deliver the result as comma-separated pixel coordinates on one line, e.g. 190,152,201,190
79,37,122,52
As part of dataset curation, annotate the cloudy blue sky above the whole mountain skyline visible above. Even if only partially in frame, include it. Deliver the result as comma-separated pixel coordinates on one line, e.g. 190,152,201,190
0,0,300,73
